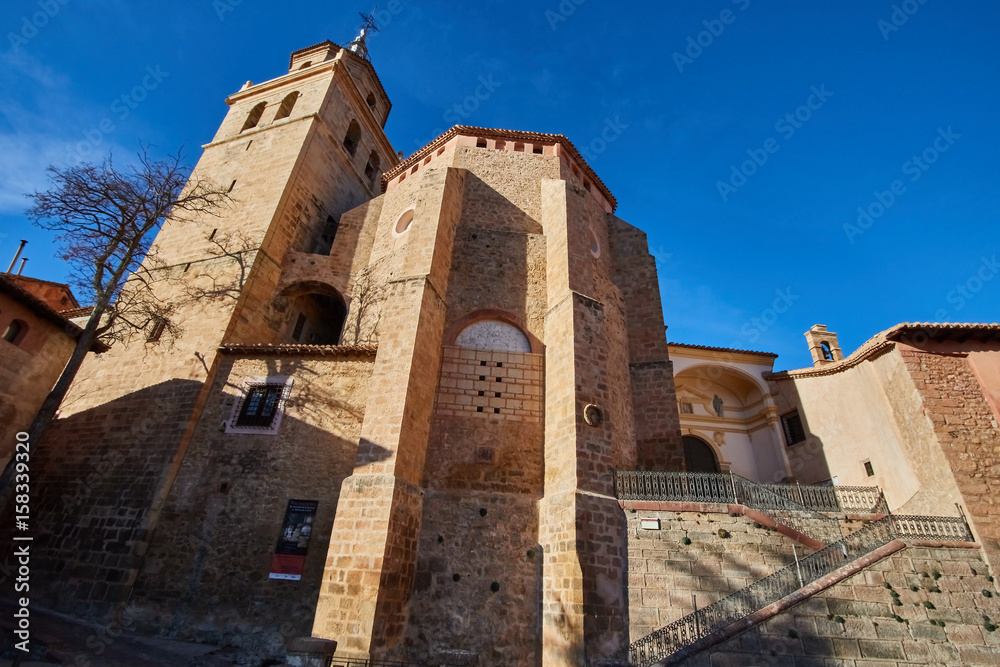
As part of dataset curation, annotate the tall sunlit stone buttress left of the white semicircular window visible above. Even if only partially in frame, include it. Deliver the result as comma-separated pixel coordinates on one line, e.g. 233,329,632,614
314,169,464,657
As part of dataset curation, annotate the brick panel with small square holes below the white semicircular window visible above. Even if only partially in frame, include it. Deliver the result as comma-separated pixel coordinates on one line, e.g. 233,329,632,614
435,346,544,421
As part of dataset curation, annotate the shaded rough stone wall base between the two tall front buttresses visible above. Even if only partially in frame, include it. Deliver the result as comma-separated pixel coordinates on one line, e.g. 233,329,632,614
405,490,542,667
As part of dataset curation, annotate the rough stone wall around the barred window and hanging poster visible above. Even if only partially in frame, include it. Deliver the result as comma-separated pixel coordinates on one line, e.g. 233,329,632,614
129,355,373,655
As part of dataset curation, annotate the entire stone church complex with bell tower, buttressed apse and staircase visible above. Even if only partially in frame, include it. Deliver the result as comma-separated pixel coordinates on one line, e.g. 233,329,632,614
11,28,1000,667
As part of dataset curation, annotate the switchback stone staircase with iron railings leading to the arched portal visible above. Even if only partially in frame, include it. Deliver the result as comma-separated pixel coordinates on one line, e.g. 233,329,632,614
617,471,973,667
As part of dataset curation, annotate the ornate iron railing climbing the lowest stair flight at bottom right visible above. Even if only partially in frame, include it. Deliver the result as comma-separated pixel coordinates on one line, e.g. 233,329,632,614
628,515,973,667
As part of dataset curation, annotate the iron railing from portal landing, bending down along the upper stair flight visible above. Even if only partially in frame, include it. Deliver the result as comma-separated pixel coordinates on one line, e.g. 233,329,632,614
616,470,843,544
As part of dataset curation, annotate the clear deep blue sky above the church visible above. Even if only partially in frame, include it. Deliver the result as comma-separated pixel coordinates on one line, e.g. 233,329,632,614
0,0,1000,368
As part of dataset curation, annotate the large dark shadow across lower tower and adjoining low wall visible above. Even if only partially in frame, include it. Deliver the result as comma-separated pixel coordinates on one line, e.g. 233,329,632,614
2,359,391,664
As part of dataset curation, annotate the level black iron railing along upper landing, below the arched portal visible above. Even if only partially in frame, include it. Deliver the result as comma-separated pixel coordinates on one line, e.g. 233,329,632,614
617,470,889,514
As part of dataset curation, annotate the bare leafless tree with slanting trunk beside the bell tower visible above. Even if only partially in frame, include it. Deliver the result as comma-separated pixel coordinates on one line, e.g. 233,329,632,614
0,149,231,507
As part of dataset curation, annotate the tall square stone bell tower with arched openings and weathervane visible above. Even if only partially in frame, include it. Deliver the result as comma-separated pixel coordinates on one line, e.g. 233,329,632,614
23,36,398,618
